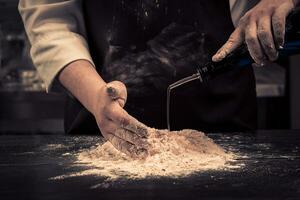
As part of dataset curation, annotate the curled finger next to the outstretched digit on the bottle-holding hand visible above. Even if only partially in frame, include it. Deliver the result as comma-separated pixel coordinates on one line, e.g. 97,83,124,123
245,22,266,65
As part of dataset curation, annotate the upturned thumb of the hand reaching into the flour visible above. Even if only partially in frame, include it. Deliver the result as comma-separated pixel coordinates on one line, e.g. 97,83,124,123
106,81,127,107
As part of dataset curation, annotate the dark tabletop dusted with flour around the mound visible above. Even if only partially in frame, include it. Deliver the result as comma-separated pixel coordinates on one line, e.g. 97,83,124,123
0,131,300,200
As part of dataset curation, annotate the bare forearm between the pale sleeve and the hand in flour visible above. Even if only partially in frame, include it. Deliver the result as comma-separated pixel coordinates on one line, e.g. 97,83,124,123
58,60,106,113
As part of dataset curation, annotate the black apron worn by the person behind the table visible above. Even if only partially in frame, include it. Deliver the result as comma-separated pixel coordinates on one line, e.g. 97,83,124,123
65,0,257,134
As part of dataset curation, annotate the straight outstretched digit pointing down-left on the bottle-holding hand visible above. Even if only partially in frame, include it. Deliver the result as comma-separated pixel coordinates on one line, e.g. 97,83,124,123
212,28,243,62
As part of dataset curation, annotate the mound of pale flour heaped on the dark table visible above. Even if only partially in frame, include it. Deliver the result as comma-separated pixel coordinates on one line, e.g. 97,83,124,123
75,128,234,179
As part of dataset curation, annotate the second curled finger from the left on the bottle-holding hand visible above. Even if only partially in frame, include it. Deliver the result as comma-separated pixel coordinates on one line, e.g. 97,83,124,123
257,15,278,61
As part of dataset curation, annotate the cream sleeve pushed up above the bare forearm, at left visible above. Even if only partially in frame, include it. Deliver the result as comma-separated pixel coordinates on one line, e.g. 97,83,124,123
19,0,94,91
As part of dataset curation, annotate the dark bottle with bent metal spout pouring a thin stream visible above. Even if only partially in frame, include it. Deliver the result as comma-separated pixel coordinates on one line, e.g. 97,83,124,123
167,7,300,131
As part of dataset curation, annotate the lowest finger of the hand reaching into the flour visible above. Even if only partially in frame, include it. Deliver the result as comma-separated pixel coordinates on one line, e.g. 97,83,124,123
106,133,148,158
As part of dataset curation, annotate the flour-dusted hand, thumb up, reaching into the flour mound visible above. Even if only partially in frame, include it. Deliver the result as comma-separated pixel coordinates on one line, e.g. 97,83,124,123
94,81,147,158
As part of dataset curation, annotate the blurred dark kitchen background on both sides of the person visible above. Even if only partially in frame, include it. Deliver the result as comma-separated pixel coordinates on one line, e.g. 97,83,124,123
0,0,300,134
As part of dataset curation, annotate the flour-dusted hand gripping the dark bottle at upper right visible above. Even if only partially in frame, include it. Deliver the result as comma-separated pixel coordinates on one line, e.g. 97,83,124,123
212,0,300,65
